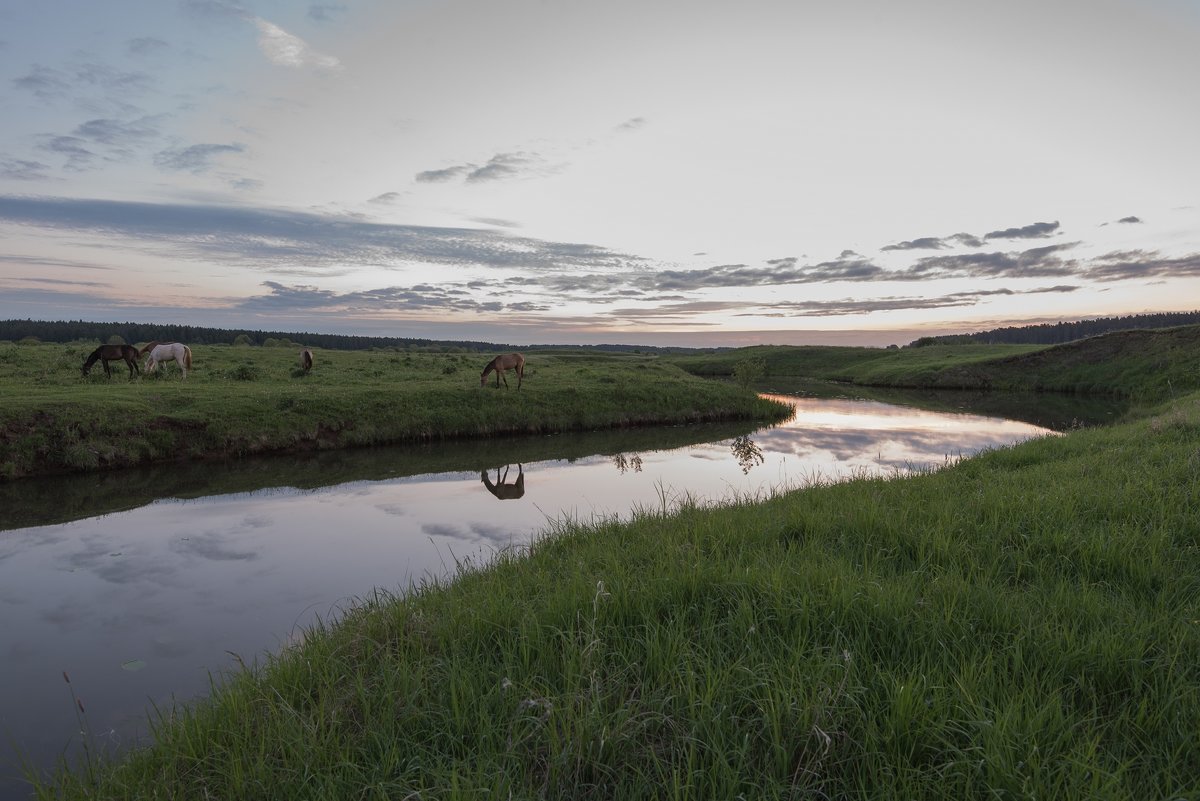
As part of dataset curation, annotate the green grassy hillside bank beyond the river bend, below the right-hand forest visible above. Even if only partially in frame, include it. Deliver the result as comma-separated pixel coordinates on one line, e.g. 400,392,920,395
666,325,1200,401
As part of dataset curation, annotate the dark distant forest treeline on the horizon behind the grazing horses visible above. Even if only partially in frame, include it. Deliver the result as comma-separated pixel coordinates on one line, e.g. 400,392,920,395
0,320,694,353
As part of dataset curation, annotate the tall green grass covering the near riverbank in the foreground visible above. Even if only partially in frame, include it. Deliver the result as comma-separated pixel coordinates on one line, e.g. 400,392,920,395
38,395,1200,800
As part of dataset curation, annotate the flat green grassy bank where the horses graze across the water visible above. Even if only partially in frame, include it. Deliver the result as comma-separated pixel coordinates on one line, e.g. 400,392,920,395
0,344,786,480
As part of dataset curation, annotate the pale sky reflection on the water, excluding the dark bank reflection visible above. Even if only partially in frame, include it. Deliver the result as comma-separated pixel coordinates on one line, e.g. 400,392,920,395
0,397,1046,797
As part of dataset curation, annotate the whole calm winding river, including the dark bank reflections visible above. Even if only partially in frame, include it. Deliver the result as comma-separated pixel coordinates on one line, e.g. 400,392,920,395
0,387,1118,799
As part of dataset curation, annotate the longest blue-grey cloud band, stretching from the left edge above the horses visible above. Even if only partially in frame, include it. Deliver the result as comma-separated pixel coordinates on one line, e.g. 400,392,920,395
0,194,643,273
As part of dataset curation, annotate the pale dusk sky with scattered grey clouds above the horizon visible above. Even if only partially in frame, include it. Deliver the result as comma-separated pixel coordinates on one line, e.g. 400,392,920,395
0,0,1200,347
